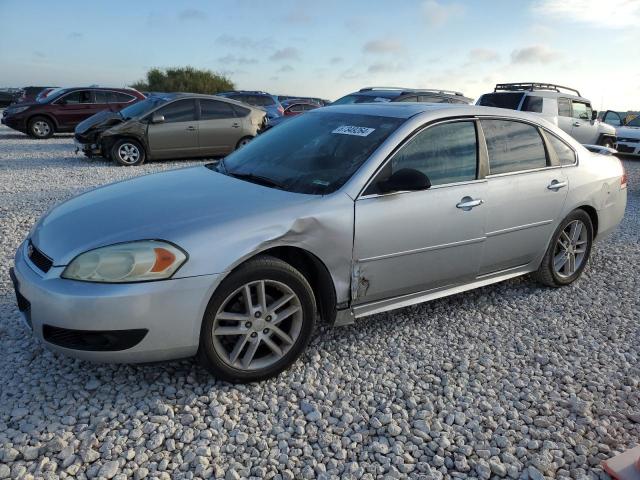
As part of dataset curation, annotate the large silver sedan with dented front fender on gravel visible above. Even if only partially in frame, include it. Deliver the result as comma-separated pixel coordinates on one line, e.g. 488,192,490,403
11,103,627,382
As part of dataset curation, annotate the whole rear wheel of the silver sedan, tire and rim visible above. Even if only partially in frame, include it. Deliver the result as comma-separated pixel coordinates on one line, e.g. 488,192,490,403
534,209,593,287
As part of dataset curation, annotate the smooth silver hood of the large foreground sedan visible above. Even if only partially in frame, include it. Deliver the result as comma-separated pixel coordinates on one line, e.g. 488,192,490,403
31,166,317,266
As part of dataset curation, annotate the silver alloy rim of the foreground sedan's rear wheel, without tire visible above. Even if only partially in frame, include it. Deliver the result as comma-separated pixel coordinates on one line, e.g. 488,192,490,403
553,220,589,278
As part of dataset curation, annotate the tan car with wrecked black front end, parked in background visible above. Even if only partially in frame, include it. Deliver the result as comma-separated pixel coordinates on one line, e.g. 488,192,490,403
75,93,266,166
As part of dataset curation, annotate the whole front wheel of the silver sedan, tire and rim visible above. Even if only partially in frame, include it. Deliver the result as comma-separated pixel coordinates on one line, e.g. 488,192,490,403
198,255,316,383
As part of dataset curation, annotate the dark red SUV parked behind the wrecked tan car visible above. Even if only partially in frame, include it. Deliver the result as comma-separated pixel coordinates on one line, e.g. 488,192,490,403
2,88,145,138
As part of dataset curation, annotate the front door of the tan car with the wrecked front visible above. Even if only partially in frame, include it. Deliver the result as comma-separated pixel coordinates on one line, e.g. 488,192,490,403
148,98,199,158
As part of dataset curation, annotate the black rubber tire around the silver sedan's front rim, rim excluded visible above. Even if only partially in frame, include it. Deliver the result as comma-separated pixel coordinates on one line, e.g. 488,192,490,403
198,255,316,383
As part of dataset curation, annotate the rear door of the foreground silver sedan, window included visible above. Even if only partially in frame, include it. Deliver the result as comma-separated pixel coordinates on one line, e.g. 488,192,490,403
479,119,569,276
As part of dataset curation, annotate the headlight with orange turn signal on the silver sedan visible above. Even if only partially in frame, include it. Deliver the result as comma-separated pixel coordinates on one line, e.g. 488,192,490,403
62,240,187,283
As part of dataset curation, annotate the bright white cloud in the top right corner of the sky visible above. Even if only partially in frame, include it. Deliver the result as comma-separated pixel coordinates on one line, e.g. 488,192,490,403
533,0,640,28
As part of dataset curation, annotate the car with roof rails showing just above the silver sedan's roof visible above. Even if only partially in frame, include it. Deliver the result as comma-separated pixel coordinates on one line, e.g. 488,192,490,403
331,87,472,105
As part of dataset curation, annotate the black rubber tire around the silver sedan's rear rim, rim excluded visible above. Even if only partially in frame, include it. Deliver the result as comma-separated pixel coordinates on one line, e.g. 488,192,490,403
534,209,593,288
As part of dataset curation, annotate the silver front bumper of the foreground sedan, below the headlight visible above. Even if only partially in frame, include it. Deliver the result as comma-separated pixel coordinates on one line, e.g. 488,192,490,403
12,242,221,363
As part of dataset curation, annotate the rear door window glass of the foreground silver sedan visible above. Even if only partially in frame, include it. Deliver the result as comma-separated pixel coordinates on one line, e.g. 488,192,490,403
481,120,547,175
